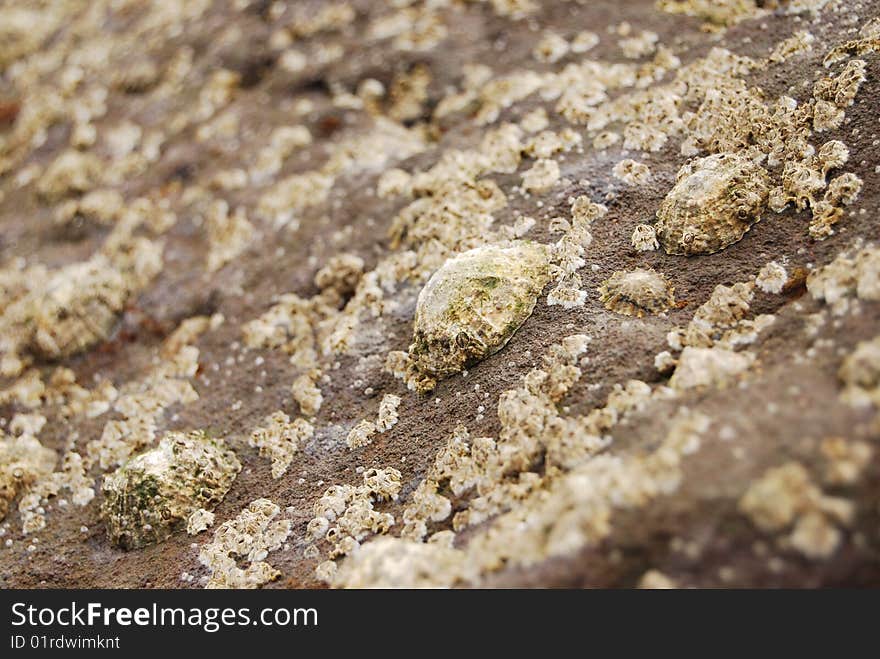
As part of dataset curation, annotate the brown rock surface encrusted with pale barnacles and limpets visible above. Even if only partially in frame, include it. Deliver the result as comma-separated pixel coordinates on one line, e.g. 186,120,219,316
0,0,880,588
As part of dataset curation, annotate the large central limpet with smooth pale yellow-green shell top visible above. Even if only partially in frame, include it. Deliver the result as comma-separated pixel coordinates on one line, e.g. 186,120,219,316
409,242,549,378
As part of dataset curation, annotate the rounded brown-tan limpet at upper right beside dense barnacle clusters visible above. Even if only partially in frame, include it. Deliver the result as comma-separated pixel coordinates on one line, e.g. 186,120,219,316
655,153,770,255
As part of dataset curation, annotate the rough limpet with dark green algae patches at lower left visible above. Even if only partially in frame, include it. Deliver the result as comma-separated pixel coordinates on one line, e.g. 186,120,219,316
101,430,241,549
